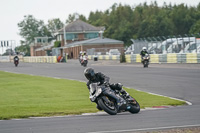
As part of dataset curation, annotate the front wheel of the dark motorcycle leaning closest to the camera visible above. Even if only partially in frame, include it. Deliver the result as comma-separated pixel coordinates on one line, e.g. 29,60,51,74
98,97,117,115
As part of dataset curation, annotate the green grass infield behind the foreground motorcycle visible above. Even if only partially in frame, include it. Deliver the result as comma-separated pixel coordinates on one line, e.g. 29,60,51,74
0,71,185,119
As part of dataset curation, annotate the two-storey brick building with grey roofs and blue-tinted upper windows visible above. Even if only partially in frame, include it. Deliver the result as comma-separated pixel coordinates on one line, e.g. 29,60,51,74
32,20,124,59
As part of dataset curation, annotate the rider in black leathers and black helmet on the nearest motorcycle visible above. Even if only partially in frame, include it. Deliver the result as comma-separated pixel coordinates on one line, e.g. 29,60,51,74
84,68,129,110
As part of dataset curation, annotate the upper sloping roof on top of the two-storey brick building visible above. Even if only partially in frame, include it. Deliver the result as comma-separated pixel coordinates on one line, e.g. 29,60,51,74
58,19,104,33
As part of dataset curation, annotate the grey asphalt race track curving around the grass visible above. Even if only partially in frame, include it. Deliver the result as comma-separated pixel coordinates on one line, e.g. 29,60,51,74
0,60,200,133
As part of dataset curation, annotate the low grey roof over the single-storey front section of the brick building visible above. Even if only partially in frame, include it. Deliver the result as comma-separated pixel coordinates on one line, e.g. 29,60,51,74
61,37,124,48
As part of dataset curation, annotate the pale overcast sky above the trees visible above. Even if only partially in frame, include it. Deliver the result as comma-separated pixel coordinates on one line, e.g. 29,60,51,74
0,0,199,43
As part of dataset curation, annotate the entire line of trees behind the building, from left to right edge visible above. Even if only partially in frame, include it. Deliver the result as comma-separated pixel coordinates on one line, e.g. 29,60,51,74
18,1,200,54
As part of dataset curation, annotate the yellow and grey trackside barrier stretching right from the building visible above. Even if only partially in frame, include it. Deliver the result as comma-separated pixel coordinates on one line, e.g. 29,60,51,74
88,53,200,63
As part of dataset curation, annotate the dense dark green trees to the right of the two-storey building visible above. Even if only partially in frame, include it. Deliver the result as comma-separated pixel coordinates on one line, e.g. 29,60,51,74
88,1,200,46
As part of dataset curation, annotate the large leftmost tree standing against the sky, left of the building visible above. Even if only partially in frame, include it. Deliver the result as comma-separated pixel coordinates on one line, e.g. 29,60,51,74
18,15,51,45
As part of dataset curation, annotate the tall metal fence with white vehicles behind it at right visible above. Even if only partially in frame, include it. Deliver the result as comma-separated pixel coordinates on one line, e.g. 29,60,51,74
130,33,200,54
